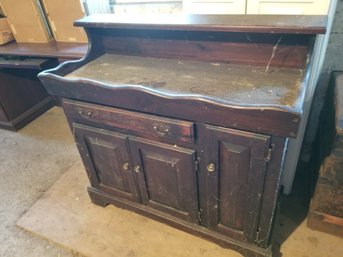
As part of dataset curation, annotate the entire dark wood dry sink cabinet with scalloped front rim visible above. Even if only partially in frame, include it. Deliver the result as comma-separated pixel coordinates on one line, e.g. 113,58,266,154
39,15,325,257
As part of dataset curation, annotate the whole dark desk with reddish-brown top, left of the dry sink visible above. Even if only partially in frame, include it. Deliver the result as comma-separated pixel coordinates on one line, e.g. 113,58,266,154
0,41,87,130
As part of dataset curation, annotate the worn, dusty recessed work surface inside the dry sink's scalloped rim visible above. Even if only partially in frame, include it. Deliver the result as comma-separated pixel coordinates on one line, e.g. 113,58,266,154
66,54,303,110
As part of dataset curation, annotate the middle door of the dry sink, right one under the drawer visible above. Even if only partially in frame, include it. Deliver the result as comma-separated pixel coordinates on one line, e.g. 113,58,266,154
130,138,198,223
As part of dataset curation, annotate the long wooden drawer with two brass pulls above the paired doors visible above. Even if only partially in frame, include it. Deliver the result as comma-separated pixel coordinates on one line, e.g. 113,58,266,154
63,100,194,143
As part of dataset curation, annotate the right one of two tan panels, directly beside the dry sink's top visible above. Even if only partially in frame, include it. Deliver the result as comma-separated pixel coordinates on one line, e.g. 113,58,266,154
42,0,87,43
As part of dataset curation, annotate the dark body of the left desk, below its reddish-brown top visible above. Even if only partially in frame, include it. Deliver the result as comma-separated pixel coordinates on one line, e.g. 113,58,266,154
0,60,57,130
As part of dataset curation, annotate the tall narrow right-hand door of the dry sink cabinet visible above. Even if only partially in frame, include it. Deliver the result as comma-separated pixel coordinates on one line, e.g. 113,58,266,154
201,125,270,241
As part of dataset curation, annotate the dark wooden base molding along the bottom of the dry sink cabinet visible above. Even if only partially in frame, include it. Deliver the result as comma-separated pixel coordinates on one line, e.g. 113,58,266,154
88,187,278,257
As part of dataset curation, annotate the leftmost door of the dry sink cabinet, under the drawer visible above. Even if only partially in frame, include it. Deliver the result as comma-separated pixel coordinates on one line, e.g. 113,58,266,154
73,124,138,201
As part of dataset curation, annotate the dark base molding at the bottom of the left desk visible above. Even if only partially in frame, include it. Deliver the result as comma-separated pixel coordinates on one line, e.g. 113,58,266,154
0,97,55,131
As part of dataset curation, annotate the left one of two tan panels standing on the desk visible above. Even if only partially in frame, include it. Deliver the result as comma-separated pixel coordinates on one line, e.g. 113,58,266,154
1,0,52,43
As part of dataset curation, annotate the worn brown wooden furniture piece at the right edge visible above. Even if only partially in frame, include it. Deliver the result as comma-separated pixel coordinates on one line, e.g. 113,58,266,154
308,72,343,237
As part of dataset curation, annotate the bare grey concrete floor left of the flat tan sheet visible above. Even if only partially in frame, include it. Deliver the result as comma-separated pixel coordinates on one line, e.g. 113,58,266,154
0,107,79,257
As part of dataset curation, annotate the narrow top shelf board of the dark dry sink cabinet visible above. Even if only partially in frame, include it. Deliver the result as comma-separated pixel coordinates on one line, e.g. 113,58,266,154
75,14,327,34
